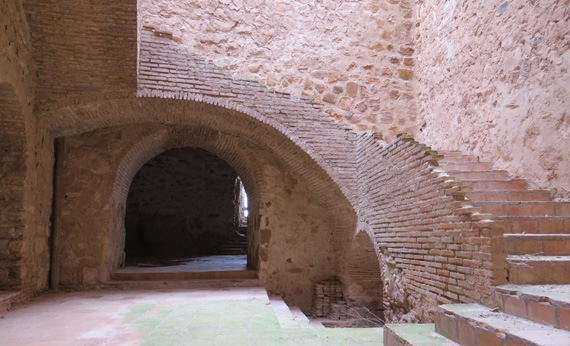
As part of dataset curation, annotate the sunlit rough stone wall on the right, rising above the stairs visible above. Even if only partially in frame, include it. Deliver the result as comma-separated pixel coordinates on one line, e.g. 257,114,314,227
416,0,570,198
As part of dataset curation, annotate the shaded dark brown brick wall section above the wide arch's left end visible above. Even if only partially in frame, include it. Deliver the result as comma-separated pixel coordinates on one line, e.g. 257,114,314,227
25,0,137,110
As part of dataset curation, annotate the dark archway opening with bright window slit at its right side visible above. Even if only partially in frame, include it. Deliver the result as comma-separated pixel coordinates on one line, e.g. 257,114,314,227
125,147,248,271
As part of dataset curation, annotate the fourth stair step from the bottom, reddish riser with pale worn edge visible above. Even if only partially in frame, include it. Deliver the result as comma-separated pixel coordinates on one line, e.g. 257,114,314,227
507,255,570,285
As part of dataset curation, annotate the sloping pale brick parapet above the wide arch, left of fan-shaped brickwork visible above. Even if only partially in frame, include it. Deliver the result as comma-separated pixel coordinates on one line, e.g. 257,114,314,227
138,28,356,203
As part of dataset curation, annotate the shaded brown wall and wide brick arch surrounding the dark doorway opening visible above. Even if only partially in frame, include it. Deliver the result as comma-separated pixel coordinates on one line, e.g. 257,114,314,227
50,99,356,310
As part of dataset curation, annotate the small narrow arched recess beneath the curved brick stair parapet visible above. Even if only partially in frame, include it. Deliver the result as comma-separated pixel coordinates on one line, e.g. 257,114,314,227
345,223,383,317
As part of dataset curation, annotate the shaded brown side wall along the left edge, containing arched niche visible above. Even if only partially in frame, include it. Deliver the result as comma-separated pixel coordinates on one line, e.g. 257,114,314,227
0,0,53,298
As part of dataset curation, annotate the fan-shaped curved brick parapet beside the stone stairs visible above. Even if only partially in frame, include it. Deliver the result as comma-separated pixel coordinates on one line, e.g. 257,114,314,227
359,134,506,321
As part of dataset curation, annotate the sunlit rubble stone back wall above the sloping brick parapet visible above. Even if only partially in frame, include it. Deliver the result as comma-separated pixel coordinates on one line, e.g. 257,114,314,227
139,0,417,140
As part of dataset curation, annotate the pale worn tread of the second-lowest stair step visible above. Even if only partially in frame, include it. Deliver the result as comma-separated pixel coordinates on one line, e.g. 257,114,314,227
438,304,570,346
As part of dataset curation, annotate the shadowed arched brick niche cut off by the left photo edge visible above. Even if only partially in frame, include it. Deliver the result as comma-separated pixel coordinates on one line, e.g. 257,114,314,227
0,83,26,290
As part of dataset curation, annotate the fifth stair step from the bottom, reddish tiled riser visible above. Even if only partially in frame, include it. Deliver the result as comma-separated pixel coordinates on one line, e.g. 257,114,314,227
504,233,570,256
